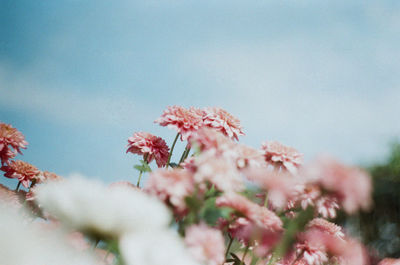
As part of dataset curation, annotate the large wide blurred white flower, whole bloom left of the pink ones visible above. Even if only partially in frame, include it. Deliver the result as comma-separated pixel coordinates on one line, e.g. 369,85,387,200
37,178,171,238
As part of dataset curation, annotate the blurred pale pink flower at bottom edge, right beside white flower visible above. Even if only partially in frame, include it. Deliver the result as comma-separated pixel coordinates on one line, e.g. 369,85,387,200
185,223,225,265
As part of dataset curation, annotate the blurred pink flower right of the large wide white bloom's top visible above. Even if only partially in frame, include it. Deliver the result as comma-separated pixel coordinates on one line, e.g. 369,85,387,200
144,169,194,216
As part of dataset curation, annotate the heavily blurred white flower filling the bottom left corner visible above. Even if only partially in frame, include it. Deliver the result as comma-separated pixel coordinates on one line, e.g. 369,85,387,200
0,203,98,265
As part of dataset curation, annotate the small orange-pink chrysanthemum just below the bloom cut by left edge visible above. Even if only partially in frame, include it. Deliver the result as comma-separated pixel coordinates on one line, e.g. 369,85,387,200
0,160,40,188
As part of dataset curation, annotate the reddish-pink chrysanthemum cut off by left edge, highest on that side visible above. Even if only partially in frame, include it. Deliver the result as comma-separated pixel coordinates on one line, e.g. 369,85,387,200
0,122,28,165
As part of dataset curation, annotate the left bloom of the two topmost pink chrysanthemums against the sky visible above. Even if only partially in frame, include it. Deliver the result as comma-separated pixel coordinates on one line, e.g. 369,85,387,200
154,106,203,140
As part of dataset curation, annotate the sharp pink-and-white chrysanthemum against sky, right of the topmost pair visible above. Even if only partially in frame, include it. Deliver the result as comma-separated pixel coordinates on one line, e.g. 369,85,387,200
261,141,303,173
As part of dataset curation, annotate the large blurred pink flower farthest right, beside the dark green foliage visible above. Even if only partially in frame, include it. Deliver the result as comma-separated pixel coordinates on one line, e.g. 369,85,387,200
304,158,372,214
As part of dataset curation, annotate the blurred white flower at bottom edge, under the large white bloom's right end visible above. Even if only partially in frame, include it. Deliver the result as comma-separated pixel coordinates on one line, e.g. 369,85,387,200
119,230,199,265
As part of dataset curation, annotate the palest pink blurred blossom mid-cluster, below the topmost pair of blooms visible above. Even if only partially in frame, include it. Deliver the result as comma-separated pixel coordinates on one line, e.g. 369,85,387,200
194,152,244,192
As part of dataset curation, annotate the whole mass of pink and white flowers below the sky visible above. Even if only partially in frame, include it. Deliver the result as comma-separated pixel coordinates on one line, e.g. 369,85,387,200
0,106,398,265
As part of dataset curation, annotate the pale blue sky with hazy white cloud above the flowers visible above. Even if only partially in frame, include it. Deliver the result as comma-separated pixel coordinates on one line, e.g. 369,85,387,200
0,0,400,182
